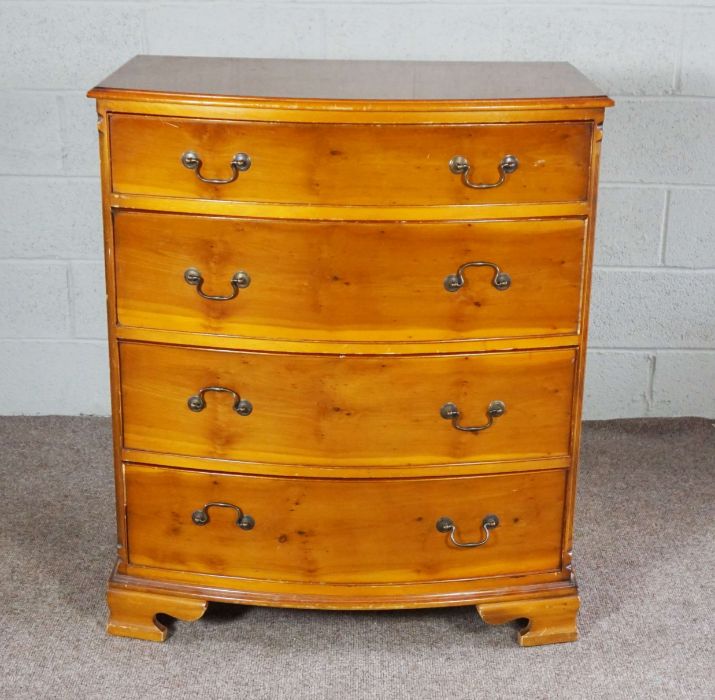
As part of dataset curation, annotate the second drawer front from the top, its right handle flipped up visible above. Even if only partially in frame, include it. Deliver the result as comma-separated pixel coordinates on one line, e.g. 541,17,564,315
114,211,585,341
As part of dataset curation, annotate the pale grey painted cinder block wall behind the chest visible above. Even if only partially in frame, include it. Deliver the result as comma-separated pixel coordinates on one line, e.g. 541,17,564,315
0,0,715,418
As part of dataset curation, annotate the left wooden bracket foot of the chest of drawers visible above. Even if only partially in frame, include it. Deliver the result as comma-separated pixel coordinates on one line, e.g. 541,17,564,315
107,584,208,642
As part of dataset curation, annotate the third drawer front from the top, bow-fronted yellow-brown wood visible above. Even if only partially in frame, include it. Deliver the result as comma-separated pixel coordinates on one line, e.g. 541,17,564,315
120,343,576,466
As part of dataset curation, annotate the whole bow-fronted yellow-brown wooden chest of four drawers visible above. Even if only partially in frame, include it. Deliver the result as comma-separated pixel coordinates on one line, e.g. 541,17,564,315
90,56,611,645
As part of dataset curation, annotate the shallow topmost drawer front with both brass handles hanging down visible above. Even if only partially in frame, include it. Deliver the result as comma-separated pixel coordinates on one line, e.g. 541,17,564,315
110,114,592,206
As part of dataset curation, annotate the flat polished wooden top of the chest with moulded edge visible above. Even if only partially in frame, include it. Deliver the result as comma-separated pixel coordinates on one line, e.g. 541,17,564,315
89,56,612,108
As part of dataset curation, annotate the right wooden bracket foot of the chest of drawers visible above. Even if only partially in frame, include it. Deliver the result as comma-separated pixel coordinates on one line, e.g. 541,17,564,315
477,594,580,647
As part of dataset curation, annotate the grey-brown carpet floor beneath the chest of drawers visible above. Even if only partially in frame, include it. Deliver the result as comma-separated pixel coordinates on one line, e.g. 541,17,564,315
0,417,715,700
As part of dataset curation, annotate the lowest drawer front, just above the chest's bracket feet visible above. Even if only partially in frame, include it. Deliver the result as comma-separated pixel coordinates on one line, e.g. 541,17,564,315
125,465,566,583
